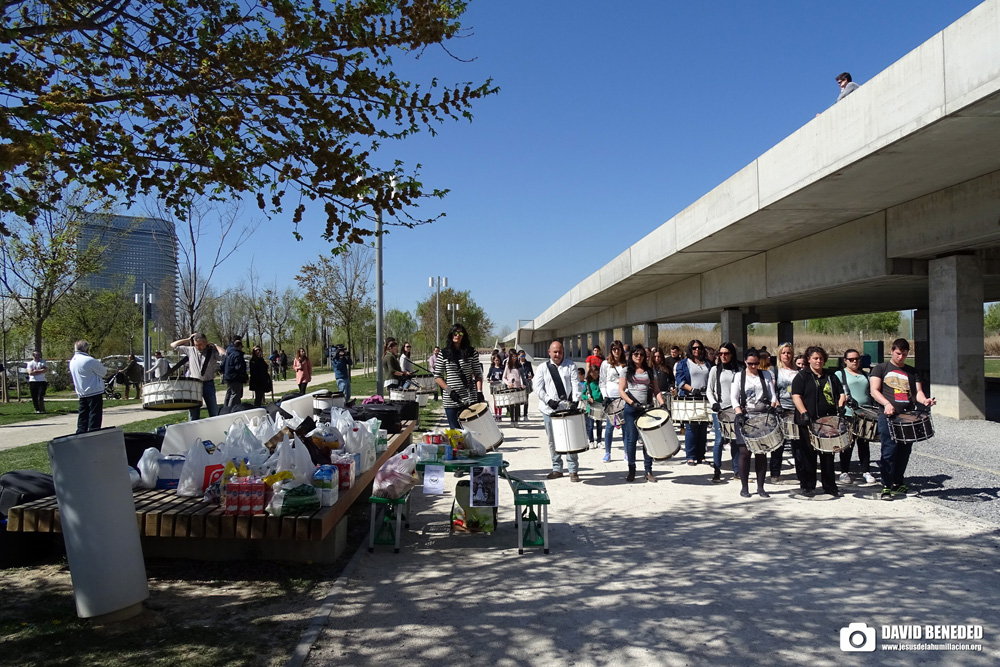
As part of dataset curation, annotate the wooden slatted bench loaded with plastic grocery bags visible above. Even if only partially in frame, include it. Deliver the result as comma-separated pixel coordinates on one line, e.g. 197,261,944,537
7,421,416,562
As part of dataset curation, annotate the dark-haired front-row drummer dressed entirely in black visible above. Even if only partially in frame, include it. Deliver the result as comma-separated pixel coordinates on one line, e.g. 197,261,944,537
792,346,846,497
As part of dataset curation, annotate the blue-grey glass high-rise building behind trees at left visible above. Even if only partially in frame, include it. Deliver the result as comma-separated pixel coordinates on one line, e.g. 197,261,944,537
77,213,178,334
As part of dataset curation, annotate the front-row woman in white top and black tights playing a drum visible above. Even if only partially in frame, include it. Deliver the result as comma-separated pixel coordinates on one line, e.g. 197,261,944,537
729,347,781,498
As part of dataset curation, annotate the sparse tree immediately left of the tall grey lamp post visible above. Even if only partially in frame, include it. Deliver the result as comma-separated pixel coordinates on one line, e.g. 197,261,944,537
295,246,373,354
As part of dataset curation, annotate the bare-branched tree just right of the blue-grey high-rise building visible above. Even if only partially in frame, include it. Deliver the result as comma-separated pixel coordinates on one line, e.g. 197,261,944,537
151,199,260,333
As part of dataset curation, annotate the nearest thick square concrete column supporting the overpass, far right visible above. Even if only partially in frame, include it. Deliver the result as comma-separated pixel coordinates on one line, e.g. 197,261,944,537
928,255,986,419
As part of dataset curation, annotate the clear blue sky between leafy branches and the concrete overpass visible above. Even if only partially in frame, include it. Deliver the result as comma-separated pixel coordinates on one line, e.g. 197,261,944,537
217,0,979,344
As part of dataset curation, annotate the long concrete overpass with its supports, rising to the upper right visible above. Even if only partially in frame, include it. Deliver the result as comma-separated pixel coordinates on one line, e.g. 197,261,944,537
517,0,1000,419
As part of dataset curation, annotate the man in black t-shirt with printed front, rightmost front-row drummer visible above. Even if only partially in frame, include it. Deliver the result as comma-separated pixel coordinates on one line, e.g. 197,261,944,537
869,338,937,500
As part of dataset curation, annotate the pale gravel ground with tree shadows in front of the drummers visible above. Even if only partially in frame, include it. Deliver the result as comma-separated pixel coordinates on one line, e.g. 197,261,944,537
307,376,1000,667
